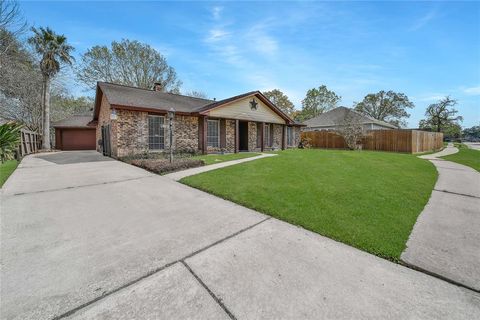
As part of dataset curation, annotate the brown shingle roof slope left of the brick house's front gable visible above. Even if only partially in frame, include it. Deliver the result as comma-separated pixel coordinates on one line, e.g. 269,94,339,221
98,82,214,112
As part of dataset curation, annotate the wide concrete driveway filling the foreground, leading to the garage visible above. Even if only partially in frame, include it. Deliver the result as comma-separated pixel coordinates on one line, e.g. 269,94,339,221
0,152,480,319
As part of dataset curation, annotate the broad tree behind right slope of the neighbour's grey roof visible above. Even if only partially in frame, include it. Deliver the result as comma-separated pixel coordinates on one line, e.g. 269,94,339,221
355,90,415,127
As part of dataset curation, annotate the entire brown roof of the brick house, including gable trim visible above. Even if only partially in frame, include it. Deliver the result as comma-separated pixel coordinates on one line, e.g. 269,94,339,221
93,82,301,125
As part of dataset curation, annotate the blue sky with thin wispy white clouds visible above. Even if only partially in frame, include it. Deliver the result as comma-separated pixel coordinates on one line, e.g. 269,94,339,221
20,2,480,127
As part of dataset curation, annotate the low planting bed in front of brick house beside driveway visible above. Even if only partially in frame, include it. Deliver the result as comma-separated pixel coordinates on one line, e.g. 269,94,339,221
129,158,204,174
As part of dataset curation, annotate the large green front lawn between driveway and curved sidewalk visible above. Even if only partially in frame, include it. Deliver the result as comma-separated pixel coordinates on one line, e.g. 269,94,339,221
181,150,437,261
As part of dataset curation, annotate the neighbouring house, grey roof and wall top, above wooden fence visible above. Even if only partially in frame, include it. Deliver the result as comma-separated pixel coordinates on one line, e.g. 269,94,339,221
302,107,398,131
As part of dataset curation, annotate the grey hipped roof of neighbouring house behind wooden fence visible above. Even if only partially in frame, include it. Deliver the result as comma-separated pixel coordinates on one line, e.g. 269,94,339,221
303,107,398,129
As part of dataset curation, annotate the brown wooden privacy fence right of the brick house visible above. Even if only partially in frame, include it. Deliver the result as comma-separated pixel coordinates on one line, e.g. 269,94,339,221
302,130,443,153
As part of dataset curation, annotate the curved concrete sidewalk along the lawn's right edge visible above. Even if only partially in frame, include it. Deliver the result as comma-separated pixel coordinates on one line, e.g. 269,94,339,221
401,145,480,291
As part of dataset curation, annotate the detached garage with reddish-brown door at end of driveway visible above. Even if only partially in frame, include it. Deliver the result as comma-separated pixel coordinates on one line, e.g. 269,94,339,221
53,116,96,150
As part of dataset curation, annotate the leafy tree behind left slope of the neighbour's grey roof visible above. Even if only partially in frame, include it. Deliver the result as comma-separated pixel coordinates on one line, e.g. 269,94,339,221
297,85,342,121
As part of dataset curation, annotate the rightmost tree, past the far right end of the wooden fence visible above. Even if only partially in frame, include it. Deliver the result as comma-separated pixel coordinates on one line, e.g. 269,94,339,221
419,96,463,132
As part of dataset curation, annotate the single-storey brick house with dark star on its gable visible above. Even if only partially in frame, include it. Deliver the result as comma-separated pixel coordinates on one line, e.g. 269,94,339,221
93,82,301,157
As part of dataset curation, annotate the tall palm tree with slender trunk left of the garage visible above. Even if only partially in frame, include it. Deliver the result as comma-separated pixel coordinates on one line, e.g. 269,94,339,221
28,27,74,149
